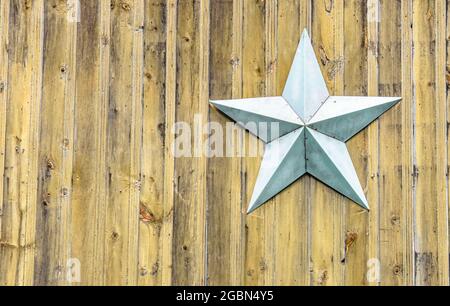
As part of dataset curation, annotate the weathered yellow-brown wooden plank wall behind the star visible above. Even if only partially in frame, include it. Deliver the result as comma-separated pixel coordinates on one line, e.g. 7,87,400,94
0,0,450,285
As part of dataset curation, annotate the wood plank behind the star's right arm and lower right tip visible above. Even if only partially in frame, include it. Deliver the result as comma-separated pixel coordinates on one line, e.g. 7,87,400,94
341,0,370,285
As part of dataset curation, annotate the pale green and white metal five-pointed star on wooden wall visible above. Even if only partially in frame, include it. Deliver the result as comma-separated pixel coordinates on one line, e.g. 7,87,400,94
211,30,401,213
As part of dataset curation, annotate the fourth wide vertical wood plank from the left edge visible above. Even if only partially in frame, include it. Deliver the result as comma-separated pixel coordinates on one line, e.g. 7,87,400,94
106,0,144,285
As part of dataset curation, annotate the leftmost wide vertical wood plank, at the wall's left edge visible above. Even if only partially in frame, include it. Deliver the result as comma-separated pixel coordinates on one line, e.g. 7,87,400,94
0,0,44,285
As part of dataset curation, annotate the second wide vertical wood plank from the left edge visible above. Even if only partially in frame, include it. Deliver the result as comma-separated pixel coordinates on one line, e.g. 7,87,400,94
35,1,77,285
